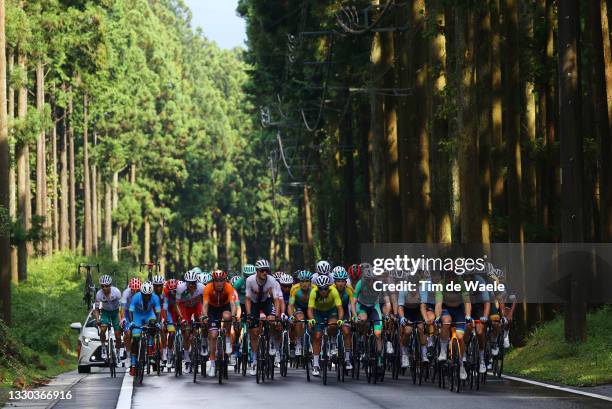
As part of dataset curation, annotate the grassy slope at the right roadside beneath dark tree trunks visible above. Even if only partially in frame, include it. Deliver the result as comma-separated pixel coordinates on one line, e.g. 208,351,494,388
504,306,612,386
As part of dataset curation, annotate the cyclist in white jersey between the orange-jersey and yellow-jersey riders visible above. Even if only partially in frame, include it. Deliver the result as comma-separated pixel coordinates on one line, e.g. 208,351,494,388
245,259,283,376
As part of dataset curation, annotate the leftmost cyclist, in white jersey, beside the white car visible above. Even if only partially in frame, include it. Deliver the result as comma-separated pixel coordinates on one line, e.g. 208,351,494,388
94,274,121,359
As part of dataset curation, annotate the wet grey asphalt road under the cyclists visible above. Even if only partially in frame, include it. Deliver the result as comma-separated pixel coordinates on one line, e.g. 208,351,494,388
5,368,612,409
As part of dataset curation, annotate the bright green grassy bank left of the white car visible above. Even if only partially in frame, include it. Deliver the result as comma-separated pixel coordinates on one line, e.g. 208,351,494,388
0,253,133,406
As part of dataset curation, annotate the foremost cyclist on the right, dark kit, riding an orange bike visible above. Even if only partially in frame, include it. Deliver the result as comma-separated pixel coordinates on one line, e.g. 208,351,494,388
435,273,472,380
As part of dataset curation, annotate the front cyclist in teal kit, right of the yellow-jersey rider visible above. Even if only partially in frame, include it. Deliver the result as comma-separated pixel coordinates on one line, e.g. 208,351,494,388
353,265,391,366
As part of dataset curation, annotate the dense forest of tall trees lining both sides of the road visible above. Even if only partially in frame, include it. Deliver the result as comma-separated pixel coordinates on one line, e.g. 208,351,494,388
0,0,612,339
